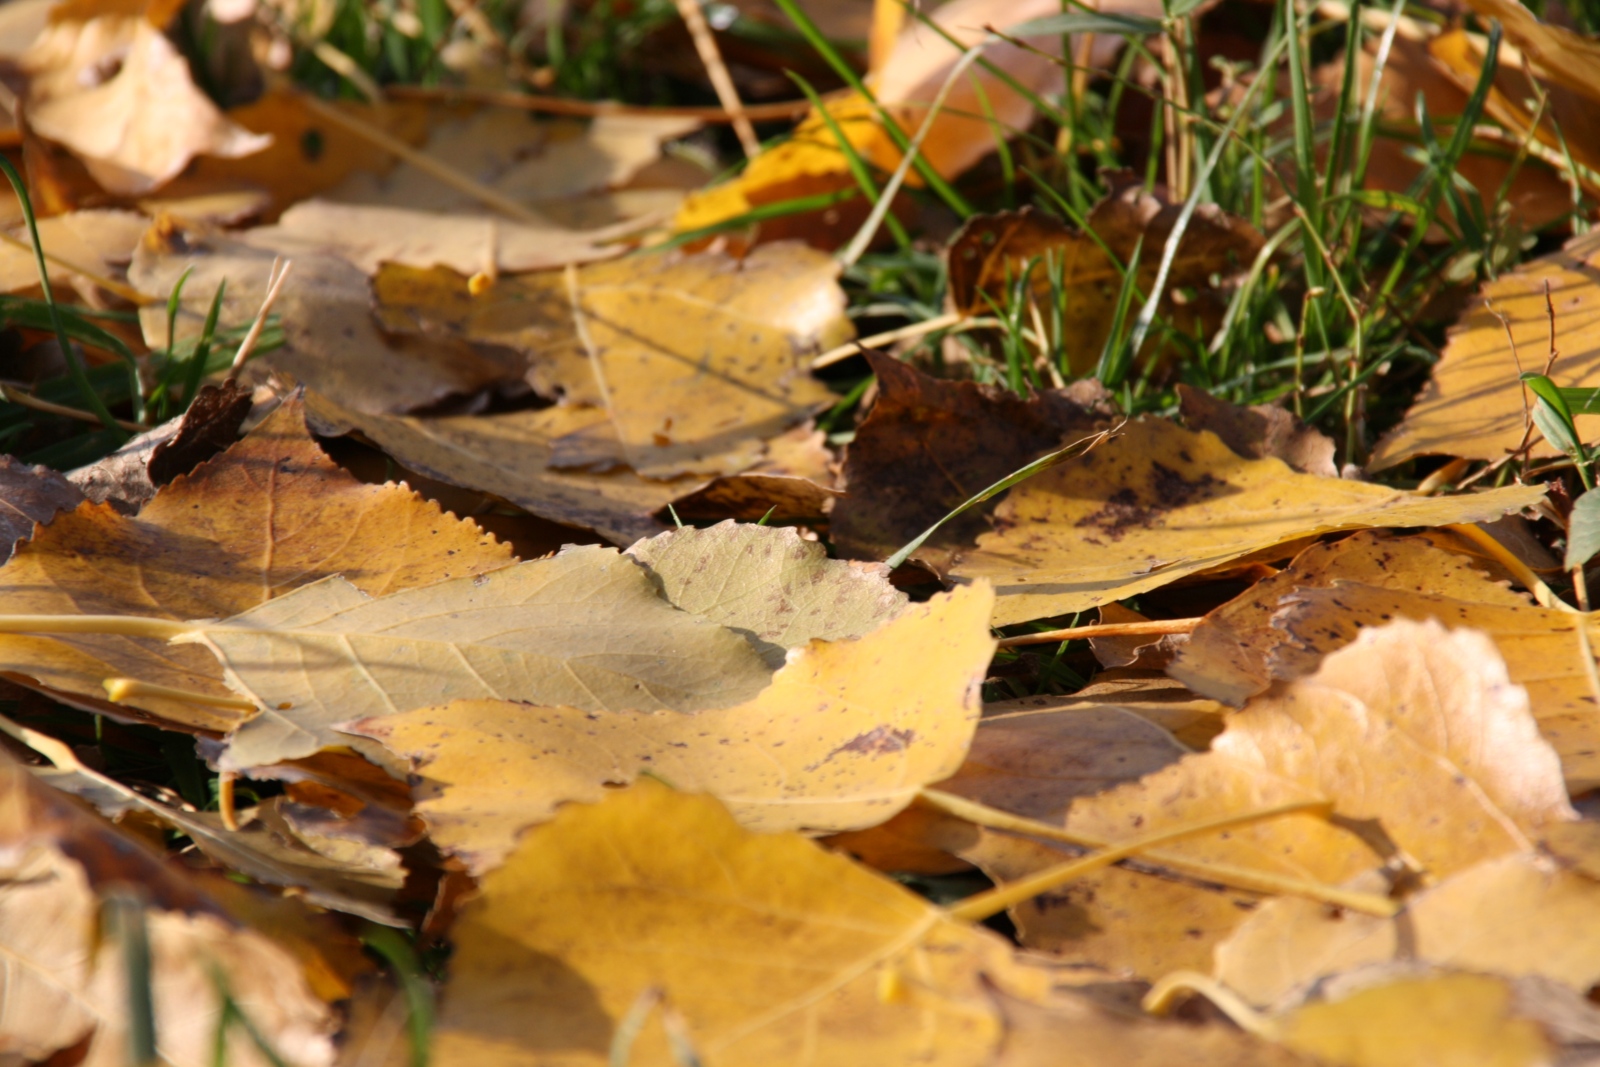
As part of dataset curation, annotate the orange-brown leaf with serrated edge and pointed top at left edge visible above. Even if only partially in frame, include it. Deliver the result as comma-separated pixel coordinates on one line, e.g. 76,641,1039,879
0,398,514,731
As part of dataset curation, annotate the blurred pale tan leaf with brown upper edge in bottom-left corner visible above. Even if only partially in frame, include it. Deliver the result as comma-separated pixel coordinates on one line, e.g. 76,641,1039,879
0,755,336,1067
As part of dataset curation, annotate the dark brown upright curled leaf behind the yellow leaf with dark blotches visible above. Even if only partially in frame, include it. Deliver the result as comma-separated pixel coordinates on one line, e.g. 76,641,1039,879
830,352,1096,569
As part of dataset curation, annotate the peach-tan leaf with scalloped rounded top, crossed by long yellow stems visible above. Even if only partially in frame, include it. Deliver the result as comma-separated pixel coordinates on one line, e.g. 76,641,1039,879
940,621,1573,977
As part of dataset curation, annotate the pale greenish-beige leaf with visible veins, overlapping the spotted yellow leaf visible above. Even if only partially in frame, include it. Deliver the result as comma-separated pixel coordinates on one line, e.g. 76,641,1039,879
200,545,771,769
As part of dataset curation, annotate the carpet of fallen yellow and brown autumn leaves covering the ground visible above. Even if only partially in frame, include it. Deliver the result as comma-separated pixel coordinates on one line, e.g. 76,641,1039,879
0,0,1600,1067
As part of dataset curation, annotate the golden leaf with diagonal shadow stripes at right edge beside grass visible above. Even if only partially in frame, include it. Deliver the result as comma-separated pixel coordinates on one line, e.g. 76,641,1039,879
1368,234,1600,470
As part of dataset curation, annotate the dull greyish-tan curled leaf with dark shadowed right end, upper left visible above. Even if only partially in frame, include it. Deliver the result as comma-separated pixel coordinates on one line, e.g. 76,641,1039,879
128,222,522,414
